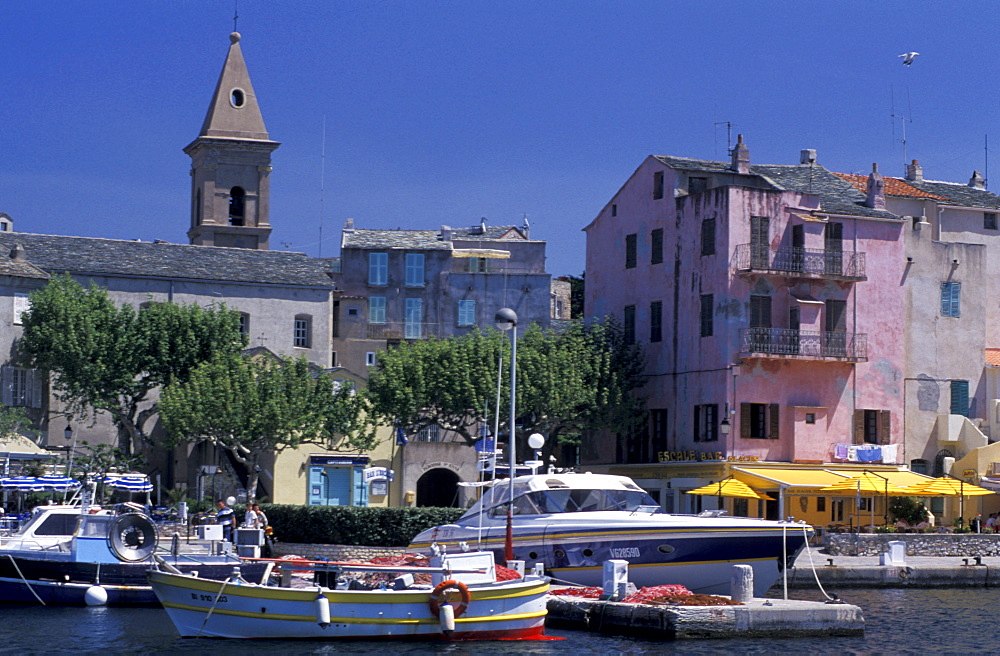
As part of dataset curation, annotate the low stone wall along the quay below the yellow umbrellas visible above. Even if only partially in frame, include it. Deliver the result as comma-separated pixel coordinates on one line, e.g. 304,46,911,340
823,533,1000,556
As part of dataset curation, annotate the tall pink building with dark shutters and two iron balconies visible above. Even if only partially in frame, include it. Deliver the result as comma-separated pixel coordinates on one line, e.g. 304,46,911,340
583,137,906,508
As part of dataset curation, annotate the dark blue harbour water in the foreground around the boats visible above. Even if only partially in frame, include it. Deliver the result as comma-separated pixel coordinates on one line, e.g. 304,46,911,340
0,588,1000,656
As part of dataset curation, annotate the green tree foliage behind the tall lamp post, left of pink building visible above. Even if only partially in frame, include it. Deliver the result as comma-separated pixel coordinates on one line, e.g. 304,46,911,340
366,320,644,456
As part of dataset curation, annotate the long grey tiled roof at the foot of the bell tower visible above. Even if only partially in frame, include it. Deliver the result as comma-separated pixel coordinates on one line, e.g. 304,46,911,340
0,232,333,287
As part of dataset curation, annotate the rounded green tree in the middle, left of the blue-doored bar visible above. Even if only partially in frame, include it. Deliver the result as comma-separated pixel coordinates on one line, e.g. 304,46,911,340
160,354,374,497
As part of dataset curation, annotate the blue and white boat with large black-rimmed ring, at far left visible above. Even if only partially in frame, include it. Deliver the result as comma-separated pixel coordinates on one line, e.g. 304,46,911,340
0,504,269,606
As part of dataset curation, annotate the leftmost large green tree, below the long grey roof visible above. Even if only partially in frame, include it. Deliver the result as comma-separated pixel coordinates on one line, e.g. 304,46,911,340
18,276,244,454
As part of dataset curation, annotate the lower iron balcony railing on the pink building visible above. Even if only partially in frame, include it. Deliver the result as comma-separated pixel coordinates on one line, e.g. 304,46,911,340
740,328,868,362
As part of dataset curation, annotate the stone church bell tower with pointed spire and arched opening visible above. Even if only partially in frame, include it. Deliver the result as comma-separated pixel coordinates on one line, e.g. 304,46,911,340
184,32,281,250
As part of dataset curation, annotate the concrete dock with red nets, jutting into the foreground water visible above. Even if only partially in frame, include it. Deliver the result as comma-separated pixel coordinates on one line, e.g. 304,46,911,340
546,591,865,640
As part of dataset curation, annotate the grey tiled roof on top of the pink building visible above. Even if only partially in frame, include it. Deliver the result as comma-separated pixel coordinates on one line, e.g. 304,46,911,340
654,155,900,220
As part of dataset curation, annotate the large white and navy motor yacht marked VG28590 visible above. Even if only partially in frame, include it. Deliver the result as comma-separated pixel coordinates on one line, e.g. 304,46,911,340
410,473,812,596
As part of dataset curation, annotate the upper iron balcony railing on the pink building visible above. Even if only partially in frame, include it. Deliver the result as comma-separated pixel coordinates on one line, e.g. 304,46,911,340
733,244,868,280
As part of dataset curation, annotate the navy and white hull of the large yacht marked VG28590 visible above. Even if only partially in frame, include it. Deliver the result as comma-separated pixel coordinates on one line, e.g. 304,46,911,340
410,518,811,596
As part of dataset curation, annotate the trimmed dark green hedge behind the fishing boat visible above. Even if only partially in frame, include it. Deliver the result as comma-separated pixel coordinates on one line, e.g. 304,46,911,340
252,504,465,547
